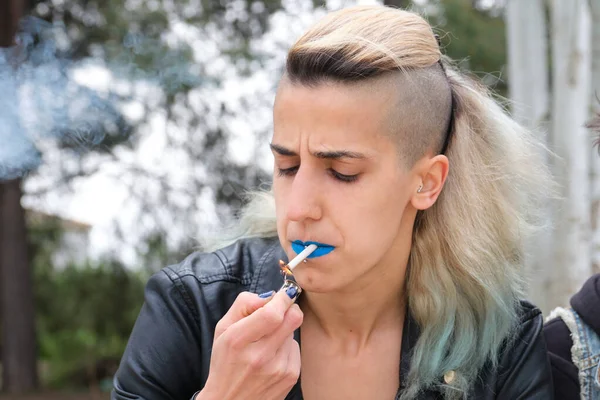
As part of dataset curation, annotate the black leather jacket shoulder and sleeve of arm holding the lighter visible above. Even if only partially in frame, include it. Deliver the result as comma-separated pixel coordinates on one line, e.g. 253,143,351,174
113,239,285,399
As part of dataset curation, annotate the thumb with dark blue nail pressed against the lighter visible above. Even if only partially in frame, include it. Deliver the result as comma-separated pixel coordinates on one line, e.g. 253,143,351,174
226,287,297,347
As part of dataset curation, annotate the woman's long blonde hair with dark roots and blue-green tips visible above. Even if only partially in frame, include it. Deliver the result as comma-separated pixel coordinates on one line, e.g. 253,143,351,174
205,6,552,399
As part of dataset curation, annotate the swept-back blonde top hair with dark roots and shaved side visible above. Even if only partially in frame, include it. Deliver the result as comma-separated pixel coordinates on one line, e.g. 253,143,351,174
283,7,453,167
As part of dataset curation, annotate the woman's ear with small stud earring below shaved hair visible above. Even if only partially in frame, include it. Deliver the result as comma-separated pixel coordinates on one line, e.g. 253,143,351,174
411,154,449,210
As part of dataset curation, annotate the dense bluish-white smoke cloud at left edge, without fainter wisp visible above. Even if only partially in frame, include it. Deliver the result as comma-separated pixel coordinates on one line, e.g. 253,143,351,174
0,17,132,181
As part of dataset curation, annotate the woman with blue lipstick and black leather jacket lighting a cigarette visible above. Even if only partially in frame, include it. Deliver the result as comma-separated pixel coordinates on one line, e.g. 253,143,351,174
113,6,552,400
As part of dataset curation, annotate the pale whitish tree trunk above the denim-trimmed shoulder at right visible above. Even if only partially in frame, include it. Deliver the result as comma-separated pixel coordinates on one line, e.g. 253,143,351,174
548,0,591,305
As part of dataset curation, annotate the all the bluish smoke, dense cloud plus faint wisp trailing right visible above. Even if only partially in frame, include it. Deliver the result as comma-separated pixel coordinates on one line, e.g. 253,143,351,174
0,17,202,181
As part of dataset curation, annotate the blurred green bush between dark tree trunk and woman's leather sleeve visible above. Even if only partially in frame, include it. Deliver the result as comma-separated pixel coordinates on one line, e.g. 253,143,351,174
30,219,147,388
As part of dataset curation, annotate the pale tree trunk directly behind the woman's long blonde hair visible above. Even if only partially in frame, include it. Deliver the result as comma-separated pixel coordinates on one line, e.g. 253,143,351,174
505,0,552,312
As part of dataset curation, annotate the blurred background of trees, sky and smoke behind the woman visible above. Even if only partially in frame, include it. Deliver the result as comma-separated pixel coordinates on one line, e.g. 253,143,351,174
0,0,600,400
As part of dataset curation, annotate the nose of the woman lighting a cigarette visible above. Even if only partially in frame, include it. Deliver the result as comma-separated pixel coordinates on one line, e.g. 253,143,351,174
287,166,322,222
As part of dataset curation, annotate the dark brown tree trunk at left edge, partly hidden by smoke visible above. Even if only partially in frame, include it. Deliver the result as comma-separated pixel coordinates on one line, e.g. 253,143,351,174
0,0,38,393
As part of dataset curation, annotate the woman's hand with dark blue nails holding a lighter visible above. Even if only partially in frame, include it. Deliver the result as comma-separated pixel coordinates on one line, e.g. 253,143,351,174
197,285,303,400
